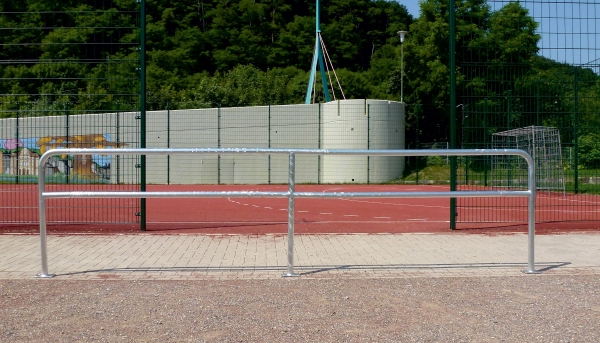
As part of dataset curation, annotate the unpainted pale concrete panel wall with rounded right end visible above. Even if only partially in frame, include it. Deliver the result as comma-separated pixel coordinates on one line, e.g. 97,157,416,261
0,99,405,184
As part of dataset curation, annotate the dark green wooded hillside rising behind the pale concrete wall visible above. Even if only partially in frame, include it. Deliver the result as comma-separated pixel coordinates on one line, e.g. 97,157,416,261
0,0,600,148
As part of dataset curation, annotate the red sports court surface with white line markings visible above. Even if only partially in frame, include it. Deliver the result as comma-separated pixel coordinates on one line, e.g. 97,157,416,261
0,185,600,235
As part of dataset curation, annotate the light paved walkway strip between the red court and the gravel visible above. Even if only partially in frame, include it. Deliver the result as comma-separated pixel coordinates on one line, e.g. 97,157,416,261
0,233,600,280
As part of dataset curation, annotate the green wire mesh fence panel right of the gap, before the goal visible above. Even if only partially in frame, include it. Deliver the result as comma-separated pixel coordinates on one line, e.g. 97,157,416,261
455,0,600,223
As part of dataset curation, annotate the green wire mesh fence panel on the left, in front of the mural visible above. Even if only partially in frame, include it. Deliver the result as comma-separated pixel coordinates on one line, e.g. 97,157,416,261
0,0,140,223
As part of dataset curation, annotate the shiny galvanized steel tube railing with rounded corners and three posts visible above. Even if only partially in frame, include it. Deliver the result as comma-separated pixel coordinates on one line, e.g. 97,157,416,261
36,148,537,278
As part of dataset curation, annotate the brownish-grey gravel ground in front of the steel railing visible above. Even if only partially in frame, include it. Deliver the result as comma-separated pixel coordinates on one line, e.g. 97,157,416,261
0,275,600,342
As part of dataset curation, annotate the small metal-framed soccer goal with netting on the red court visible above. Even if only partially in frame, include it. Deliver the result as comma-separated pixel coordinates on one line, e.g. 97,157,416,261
491,126,565,193
